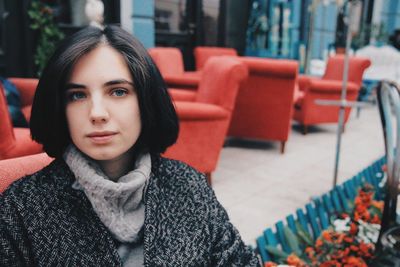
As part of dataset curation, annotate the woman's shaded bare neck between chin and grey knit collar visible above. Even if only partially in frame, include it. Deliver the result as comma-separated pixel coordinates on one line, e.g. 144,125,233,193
97,151,135,182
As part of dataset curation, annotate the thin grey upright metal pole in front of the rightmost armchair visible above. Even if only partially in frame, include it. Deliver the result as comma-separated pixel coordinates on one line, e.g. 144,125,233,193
333,1,354,187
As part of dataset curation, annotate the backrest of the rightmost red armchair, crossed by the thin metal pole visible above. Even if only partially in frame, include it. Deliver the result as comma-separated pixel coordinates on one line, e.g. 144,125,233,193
322,55,371,86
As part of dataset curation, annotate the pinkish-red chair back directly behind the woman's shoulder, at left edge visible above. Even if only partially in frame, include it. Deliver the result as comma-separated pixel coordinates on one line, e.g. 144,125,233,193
0,153,53,194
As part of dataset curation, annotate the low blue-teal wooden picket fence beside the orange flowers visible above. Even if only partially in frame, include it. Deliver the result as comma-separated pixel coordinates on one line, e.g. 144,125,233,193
256,157,386,263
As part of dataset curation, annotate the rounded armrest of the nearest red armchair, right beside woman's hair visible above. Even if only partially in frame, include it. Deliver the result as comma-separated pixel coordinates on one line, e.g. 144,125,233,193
175,101,230,121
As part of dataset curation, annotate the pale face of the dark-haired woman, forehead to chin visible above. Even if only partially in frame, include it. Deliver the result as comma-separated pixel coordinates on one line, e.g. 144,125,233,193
66,45,141,161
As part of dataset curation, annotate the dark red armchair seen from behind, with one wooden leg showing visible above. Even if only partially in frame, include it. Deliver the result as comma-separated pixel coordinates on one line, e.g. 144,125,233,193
228,57,298,153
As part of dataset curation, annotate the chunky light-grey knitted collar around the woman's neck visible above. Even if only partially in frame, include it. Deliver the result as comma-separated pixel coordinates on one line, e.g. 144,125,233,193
63,145,151,242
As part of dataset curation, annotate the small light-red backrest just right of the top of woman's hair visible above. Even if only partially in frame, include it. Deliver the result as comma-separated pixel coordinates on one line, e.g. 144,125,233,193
148,47,185,77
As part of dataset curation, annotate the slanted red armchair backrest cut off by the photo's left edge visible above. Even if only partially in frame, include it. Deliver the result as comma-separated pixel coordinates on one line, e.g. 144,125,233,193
0,84,15,155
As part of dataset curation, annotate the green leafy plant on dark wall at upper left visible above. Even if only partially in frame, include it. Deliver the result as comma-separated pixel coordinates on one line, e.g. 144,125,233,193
28,1,64,76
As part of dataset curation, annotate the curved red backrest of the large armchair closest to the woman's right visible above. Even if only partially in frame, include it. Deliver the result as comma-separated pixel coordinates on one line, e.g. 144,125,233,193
196,57,248,111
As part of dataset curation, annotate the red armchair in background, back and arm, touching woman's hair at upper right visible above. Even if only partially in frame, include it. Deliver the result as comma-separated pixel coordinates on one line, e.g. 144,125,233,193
148,47,201,89
